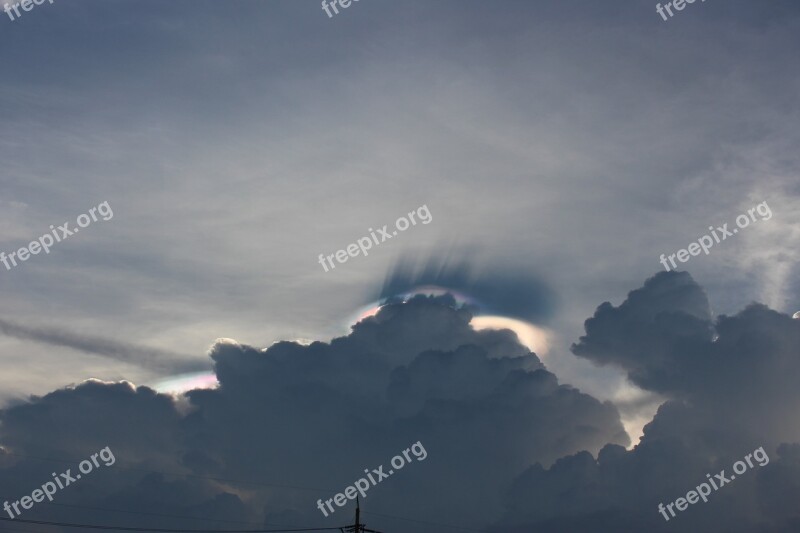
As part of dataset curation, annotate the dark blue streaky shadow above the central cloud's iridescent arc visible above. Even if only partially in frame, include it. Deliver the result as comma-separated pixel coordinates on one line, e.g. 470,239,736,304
380,257,555,323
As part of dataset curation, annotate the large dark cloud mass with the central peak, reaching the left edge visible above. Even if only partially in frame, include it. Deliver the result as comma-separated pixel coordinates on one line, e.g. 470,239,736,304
0,296,628,531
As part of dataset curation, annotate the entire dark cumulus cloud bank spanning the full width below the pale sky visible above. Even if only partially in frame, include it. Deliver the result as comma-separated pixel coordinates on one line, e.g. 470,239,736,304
0,278,800,533
